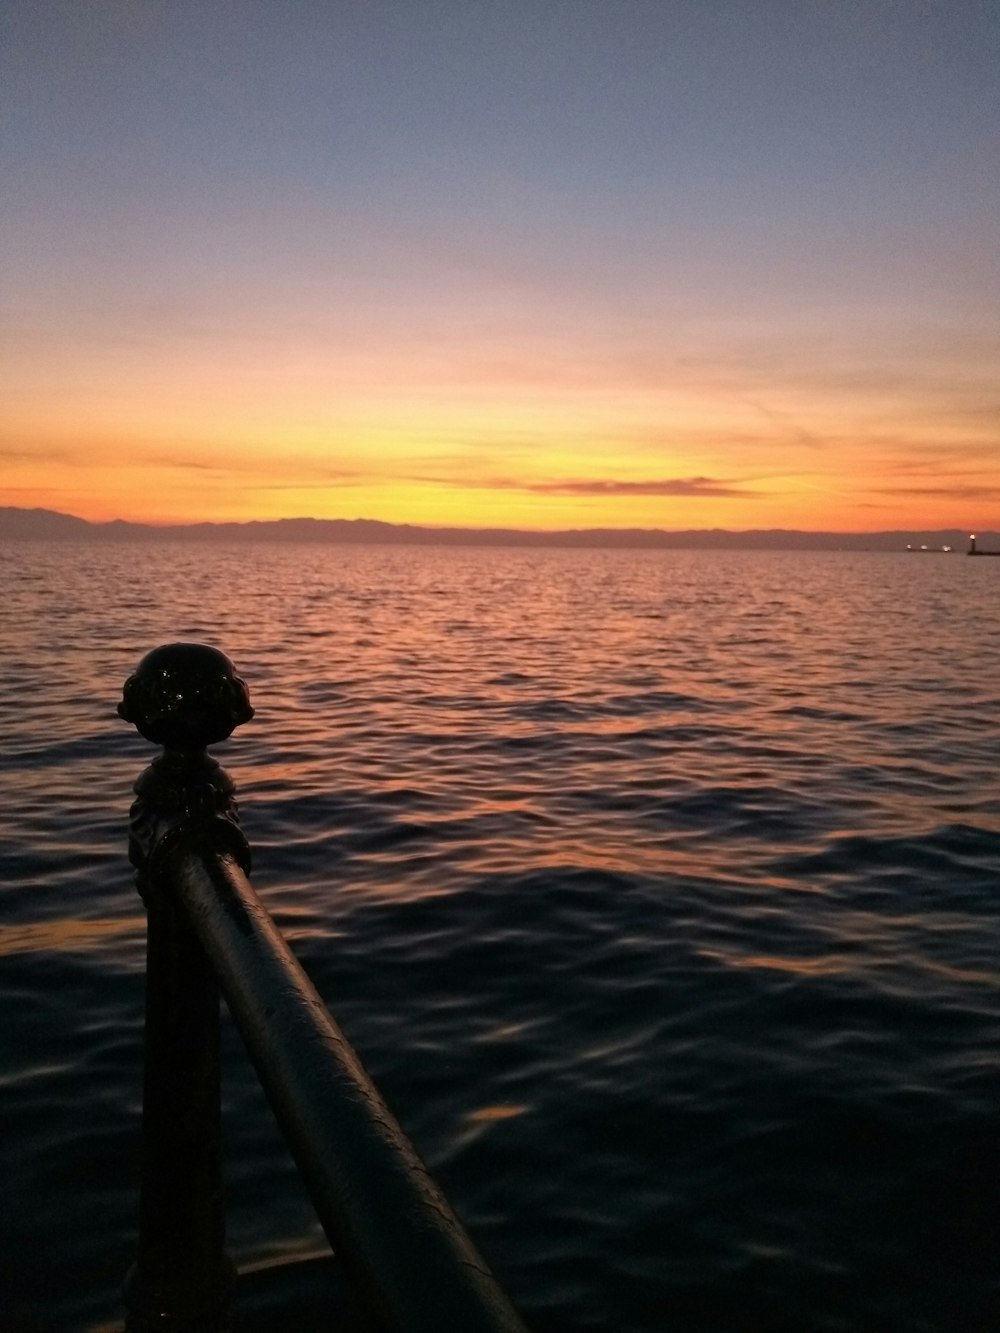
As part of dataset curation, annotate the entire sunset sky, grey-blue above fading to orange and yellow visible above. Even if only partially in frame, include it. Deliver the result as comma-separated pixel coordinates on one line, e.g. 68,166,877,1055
0,0,1000,532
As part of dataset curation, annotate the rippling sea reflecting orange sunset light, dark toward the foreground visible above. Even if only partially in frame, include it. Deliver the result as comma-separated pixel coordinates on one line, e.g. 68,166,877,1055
0,541,1000,1333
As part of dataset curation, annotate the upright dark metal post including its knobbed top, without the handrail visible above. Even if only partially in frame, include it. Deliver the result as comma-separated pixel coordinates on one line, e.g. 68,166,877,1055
119,644,253,1333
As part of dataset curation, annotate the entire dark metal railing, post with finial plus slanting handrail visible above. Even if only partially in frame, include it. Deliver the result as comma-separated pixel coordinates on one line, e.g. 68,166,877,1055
119,644,533,1333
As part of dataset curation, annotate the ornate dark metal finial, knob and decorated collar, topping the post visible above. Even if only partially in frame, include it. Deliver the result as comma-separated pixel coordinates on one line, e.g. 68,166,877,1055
119,644,253,897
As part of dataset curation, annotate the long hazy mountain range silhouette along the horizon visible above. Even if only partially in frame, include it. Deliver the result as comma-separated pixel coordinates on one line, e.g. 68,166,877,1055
0,507,1000,553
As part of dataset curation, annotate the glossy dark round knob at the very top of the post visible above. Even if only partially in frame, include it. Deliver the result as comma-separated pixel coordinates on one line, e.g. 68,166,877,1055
119,644,253,752
